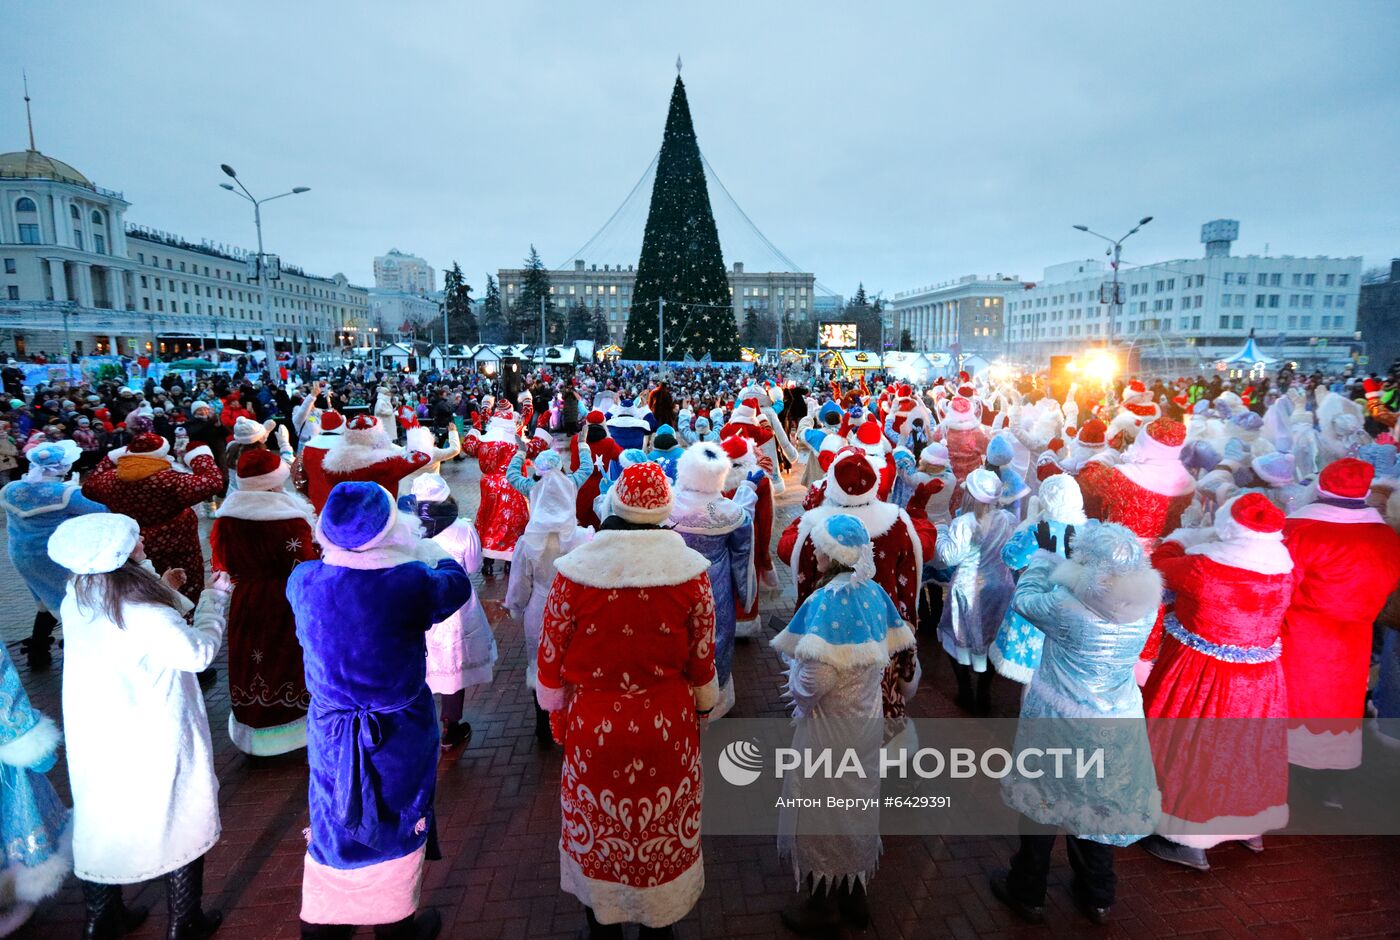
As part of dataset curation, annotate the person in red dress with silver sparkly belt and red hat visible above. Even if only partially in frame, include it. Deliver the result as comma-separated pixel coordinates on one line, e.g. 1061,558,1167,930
1141,493,1296,871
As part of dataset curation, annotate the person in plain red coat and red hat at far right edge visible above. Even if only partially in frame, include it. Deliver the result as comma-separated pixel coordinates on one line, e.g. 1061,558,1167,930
1284,457,1400,770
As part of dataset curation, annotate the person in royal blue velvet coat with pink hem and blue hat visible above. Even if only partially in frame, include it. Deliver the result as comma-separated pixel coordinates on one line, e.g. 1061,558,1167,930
287,482,472,940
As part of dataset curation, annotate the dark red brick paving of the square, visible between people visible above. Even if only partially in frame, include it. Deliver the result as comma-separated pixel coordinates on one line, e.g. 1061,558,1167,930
0,461,1400,940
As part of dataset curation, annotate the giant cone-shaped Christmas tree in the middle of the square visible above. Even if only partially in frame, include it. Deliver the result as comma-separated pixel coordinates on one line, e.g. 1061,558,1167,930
623,76,739,361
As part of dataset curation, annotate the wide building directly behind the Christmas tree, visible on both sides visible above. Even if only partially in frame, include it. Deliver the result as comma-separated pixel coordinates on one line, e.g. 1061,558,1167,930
497,259,816,343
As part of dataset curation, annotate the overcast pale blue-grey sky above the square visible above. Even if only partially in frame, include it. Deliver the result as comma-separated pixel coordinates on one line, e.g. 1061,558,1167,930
0,0,1400,294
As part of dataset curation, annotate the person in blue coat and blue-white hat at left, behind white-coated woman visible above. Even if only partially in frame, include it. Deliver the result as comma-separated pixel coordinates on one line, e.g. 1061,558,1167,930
0,441,106,672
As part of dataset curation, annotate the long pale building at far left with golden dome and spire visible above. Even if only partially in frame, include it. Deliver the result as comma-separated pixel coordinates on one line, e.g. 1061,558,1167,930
0,141,368,356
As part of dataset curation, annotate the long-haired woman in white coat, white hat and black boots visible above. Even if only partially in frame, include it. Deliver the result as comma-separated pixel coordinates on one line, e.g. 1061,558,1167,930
49,513,232,940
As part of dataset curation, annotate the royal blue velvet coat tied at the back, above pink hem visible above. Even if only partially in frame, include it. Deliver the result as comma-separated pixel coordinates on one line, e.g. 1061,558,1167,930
287,555,472,869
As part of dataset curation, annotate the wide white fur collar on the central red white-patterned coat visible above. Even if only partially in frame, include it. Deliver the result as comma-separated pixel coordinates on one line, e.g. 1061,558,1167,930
554,530,710,590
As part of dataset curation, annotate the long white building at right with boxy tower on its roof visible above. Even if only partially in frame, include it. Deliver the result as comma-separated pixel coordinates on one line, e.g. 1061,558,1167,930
1005,220,1361,374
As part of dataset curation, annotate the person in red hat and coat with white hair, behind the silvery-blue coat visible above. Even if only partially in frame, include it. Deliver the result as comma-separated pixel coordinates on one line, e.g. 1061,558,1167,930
1077,417,1196,668
